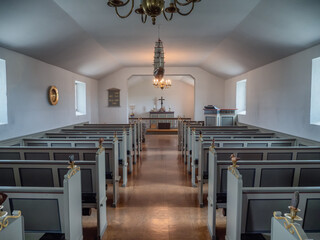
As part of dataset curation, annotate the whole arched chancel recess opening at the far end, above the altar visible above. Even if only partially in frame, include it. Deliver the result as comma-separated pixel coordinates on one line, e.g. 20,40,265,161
128,74,195,119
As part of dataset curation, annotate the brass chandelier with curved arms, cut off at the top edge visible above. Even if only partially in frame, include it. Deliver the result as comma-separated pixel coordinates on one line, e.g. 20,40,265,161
108,0,201,25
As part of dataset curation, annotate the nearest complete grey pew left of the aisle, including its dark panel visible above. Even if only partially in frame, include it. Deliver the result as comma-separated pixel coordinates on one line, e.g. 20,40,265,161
0,168,83,240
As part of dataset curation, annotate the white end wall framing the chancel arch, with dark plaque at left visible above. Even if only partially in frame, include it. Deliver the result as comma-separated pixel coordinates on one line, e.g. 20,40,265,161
99,67,224,123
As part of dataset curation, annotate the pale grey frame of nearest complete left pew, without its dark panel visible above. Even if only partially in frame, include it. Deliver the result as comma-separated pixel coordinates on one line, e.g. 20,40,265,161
0,169,83,240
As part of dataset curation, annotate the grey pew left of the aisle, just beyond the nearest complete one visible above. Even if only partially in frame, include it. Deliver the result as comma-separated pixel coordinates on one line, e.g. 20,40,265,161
0,148,108,237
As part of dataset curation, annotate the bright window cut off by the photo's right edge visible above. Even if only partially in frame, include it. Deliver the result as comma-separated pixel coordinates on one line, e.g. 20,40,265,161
310,57,320,125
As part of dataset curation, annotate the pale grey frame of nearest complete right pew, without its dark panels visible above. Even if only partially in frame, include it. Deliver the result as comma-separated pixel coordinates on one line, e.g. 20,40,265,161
224,167,320,240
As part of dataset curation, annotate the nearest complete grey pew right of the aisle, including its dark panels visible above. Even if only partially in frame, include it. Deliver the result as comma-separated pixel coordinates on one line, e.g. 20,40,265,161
221,167,320,240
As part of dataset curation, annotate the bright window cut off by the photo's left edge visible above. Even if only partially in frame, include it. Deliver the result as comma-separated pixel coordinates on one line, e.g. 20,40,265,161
0,59,8,125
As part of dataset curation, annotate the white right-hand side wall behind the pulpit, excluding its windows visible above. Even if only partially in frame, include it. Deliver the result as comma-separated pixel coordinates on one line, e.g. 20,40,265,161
225,45,320,141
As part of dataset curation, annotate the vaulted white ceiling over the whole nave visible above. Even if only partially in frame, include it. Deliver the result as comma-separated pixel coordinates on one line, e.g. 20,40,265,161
0,0,320,79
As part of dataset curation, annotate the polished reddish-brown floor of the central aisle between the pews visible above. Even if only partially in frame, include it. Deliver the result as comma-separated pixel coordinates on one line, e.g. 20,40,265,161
83,135,225,240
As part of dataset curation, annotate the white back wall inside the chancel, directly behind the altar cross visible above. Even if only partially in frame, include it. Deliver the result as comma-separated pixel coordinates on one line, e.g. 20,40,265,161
128,76,194,119
